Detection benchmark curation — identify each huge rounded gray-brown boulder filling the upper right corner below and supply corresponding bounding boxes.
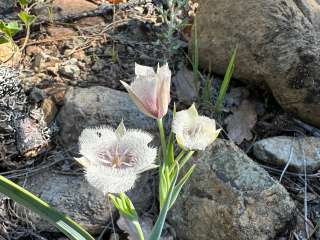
[197,0,320,126]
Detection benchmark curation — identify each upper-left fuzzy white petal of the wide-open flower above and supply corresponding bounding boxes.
[79,127,118,163]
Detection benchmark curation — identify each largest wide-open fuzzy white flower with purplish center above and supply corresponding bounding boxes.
[76,122,157,194]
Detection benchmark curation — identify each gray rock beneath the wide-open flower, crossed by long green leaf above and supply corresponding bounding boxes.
[17,170,153,234]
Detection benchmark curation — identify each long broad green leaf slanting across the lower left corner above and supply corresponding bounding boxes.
[0,175,94,240]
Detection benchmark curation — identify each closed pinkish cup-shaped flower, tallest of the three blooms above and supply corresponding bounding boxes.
[121,63,171,119]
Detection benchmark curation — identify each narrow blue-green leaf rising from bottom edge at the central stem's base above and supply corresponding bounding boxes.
[149,166,179,240]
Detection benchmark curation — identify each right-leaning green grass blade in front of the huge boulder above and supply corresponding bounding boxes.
[215,47,238,113]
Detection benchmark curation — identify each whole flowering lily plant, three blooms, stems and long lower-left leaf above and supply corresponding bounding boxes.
[0,64,220,240]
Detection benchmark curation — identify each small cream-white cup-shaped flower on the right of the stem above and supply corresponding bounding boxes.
[172,104,221,150]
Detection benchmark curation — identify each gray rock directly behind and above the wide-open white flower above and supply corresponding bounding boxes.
[57,86,158,146]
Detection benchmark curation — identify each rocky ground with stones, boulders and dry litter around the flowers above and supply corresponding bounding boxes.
[0,0,320,240]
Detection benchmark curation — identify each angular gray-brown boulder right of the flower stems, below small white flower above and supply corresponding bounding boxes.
[169,140,296,240]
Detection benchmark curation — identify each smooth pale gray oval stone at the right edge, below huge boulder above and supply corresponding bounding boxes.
[253,136,320,173]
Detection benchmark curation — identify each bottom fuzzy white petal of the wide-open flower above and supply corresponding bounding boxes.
[86,165,138,194]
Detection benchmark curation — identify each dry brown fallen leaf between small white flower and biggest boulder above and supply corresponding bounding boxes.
[225,100,257,144]
